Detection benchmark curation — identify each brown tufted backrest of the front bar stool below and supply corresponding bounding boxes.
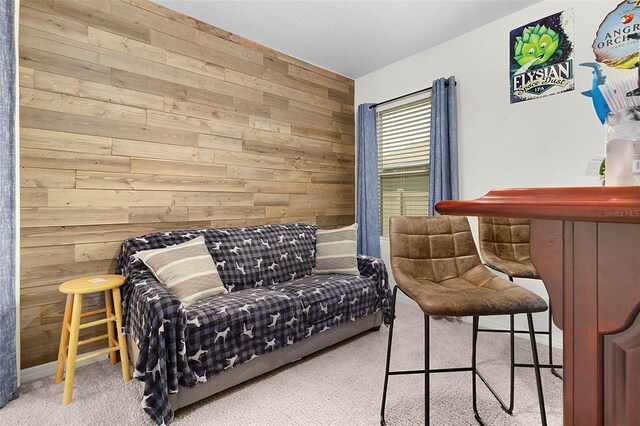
[389,216,481,283]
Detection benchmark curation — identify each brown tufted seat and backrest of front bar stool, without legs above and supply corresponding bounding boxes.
[389,216,547,316]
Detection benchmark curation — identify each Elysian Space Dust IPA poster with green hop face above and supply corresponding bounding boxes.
[509,9,575,104]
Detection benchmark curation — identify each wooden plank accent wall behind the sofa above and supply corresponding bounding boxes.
[20,0,355,368]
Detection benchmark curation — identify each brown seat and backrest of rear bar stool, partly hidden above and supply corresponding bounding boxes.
[478,217,540,279]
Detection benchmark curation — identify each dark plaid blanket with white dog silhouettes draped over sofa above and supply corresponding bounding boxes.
[117,224,391,424]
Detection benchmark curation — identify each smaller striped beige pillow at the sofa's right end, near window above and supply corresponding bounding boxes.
[313,223,360,275]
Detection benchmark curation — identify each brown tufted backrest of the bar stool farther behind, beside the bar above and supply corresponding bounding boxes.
[478,217,531,262]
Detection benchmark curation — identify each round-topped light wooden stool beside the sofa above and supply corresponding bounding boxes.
[54,275,131,404]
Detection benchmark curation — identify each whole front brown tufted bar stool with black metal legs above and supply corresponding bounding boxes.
[380,216,547,426]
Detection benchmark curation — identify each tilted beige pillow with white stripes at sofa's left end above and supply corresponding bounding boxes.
[137,236,227,307]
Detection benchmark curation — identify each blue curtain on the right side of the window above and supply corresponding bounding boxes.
[429,77,458,216]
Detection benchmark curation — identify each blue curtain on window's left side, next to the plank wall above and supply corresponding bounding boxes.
[356,104,380,258]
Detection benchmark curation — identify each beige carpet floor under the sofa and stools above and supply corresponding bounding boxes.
[0,303,562,426]
